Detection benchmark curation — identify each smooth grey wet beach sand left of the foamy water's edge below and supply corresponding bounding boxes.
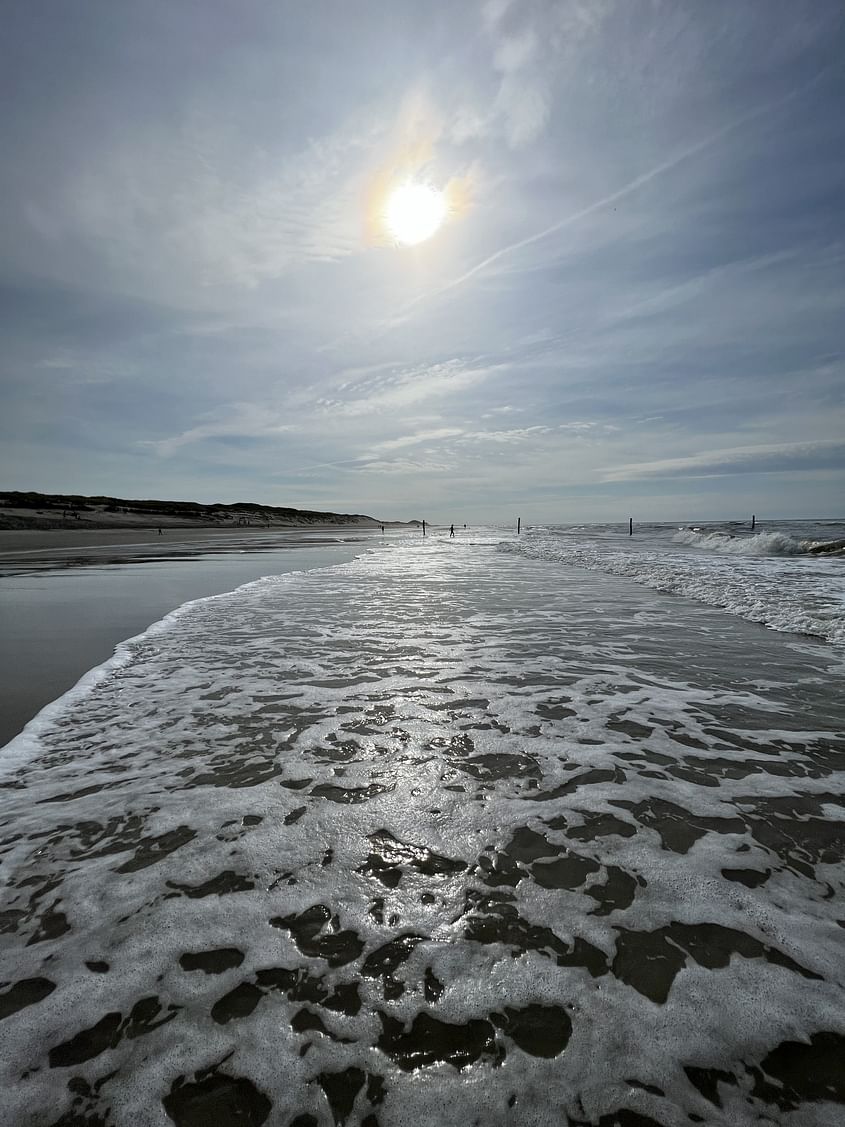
[0,529,372,747]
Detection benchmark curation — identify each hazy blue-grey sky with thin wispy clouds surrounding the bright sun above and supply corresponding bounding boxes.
[0,0,845,524]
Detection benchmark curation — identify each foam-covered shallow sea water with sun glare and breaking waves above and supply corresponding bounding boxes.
[0,522,845,1127]
